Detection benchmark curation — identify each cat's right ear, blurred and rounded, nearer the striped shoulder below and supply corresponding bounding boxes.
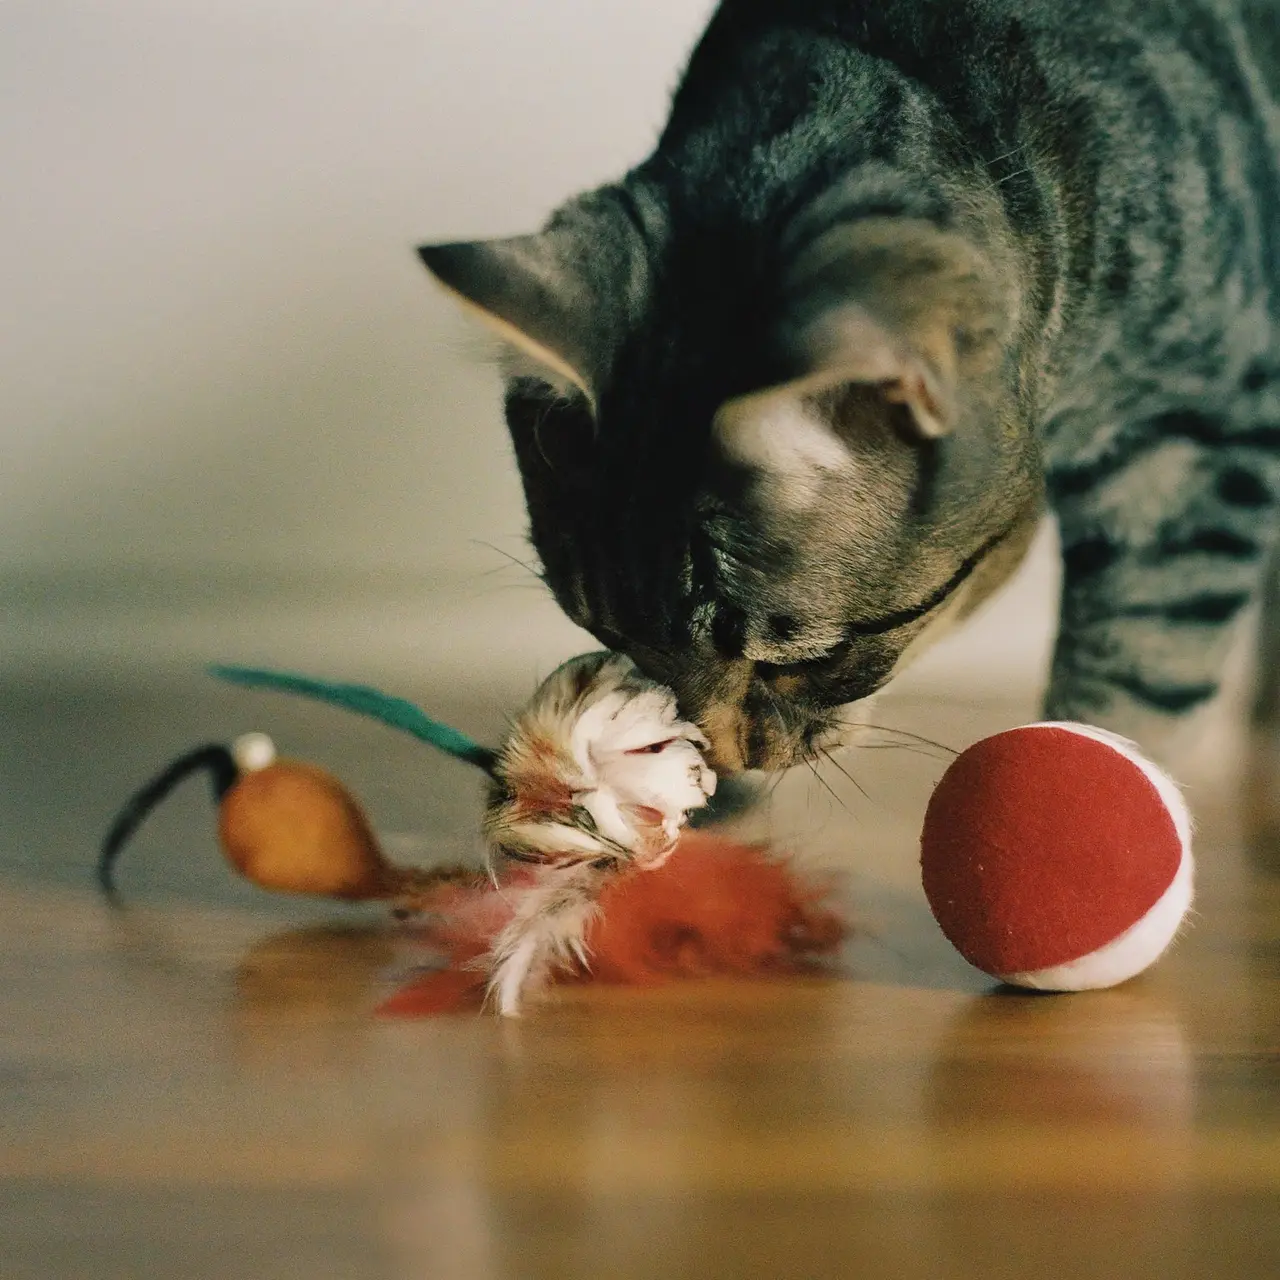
[774,218,1007,438]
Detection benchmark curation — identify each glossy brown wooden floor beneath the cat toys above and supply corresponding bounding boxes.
[0,682,1280,1280]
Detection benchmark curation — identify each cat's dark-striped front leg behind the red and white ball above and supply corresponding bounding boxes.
[1046,412,1280,760]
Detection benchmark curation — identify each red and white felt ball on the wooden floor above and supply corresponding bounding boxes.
[920,723,1192,991]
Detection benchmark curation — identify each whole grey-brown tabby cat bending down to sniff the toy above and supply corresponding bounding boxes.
[421,0,1280,771]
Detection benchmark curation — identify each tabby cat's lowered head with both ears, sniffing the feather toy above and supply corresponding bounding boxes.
[421,180,1041,772]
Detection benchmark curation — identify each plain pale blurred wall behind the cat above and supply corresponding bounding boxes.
[0,0,1056,695]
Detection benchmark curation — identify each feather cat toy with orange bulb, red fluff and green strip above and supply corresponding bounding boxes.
[99,653,844,1015]
